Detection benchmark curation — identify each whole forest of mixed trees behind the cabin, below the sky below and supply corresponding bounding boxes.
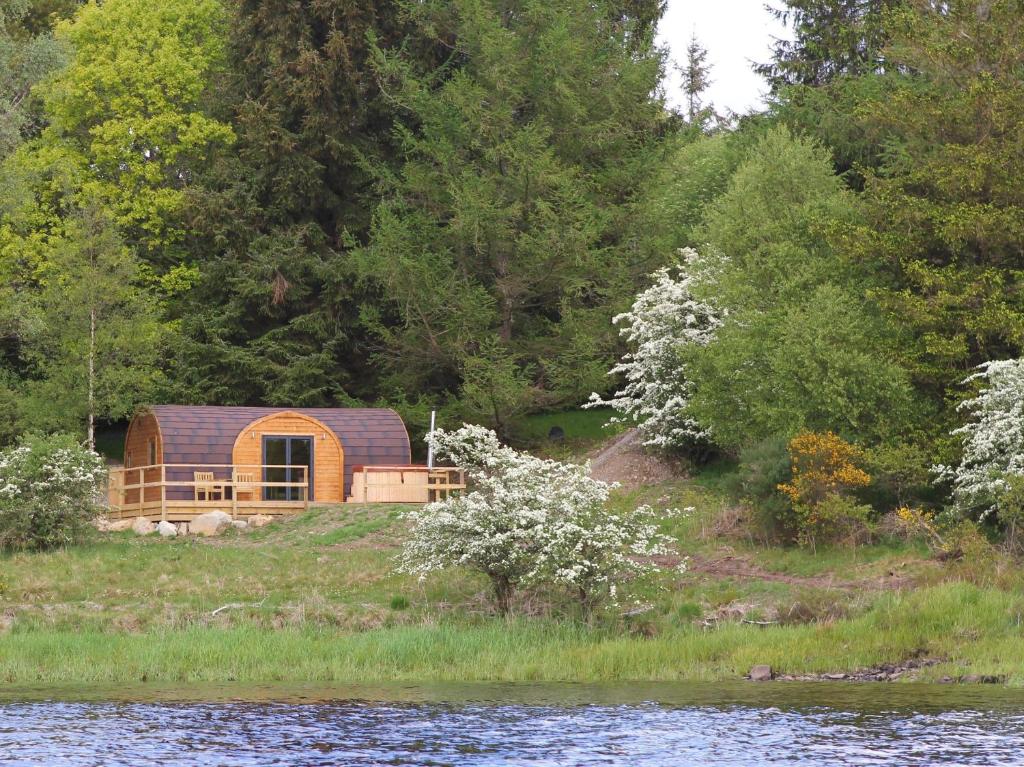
[0,0,1024,520]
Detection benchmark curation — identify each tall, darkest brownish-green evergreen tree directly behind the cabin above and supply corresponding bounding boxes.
[178,0,425,406]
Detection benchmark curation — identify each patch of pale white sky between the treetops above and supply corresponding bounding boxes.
[658,0,788,114]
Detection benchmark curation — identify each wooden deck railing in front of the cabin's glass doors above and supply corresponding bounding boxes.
[108,464,309,519]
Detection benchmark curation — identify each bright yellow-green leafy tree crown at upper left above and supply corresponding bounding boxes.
[8,0,232,268]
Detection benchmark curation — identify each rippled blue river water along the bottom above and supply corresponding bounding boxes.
[0,682,1024,767]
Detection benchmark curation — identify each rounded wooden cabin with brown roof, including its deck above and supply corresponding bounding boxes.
[111,404,461,521]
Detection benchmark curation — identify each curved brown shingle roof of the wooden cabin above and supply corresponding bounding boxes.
[146,404,412,496]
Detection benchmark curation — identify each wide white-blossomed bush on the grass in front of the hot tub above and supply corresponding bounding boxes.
[399,425,669,613]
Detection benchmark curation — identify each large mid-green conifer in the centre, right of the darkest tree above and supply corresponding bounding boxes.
[357,0,668,423]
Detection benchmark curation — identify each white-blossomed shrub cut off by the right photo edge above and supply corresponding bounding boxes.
[935,359,1024,516]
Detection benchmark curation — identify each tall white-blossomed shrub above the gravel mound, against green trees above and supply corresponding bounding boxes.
[584,248,722,450]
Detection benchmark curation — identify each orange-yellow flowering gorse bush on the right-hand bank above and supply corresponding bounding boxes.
[778,431,871,506]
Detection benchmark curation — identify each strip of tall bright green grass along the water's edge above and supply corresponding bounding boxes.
[8,583,1024,685]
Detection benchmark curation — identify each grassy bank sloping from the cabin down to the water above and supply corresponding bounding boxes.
[0,481,1024,685]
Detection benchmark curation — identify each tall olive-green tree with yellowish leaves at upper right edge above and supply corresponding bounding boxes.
[834,0,1024,431]
